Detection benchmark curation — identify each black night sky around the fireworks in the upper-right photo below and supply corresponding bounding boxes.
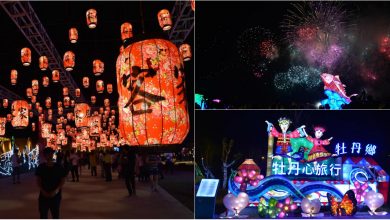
[195,1,390,108]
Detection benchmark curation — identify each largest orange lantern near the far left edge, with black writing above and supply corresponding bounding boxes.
[11,100,28,129]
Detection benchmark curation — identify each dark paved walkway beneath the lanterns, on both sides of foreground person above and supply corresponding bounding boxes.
[0,168,194,219]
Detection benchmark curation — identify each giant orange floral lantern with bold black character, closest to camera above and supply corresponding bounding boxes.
[116,39,190,146]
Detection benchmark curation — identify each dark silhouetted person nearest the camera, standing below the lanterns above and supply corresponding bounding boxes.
[35,147,66,219]
